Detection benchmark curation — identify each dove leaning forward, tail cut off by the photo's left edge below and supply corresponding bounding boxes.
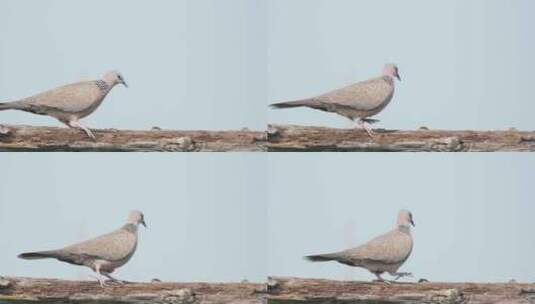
[0,71,128,140]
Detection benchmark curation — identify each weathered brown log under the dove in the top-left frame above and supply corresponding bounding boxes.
[0,126,266,152]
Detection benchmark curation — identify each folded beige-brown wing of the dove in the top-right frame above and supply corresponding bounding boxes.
[314,77,394,111]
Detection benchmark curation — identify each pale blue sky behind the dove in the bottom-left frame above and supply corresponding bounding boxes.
[0,154,267,282]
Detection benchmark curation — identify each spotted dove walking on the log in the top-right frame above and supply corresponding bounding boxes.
[270,63,401,138]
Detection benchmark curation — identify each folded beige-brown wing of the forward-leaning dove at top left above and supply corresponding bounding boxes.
[18,81,103,113]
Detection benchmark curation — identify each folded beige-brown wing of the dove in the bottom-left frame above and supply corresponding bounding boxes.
[62,228,137,261]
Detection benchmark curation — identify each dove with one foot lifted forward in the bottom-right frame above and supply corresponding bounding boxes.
[305,210,415,282]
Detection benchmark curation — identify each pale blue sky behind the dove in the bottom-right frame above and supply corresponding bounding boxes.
[268,154,535,282]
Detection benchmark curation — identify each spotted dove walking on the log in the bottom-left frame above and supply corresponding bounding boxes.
[18,210,147,287]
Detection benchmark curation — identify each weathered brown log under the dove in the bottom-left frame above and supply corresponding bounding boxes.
[0,278,265,304]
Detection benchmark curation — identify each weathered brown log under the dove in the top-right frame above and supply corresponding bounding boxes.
[268,125,535,152]
